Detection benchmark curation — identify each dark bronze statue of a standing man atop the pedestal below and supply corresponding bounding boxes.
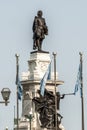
[32,10,48,51]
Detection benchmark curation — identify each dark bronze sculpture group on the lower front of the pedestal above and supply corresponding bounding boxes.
[32,89,64,130]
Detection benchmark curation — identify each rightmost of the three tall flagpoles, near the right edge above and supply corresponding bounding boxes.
[79,52,84,130]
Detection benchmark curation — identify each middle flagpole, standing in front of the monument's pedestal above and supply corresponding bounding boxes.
[53,53,58,130]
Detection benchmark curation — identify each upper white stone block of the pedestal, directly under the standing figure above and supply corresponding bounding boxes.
[28,52,50,80]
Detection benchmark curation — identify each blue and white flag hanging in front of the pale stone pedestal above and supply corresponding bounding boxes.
[40,62,51,96]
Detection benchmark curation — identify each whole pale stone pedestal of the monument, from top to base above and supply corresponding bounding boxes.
[15,52,63,130]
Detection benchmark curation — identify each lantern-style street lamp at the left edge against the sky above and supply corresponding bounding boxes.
[0,88,11,106]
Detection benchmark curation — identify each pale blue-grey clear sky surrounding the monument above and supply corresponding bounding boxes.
[0,0,87,130]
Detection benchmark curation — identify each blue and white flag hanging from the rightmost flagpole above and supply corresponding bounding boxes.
[74,63,82,95]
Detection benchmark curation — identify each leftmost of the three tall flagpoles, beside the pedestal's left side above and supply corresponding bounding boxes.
[15,54,19,130]
